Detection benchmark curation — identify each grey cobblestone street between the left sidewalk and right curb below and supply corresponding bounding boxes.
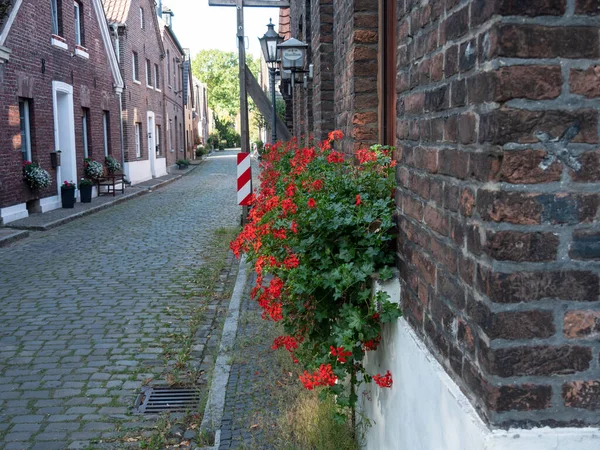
[0,152,240,450]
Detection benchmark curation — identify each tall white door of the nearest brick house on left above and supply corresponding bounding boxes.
[52,81,77,194]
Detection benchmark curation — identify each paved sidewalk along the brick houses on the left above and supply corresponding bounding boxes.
[0,159,204,247]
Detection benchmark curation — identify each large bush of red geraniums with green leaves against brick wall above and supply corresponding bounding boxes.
[231,131,401,419]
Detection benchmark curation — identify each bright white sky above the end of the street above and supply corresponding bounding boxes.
[163,0,279,57]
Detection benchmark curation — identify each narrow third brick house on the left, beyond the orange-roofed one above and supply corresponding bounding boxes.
[159,5,185,171]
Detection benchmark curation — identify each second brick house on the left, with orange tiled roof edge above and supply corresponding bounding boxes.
[104,0,167,184]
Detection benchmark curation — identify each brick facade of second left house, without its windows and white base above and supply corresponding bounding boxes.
[115,0,164,162]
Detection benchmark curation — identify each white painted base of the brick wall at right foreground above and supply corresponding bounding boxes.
[359,286,600,450]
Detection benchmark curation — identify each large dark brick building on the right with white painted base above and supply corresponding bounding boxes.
[286,0,600,449]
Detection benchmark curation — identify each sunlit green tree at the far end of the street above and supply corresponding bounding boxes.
[192,49,259,120]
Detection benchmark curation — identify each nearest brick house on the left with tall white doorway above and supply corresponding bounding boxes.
[0,0,123,223]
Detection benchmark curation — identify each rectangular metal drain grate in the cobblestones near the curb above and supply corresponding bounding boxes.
[133,386,200,414]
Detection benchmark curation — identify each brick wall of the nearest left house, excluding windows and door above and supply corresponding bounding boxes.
[0,0,121,207]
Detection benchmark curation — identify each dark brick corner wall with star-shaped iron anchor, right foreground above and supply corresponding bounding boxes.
[397,0,600,426]
